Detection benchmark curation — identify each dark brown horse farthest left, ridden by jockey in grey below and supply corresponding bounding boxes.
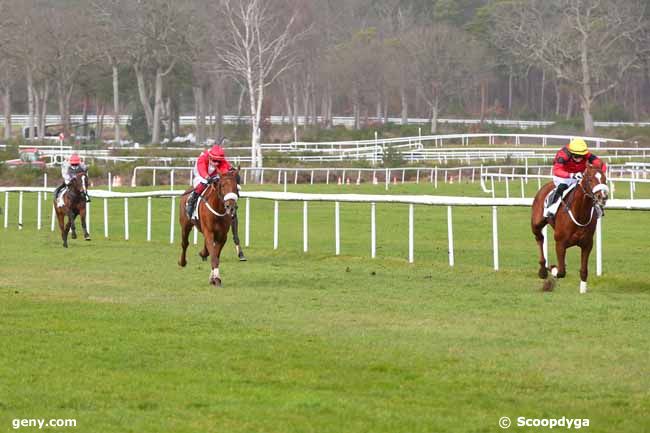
[54,170,90,248]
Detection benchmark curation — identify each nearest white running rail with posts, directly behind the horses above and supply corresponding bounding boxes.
[0,187,650,275]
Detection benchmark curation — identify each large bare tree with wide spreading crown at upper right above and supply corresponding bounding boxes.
[493,0,650,134]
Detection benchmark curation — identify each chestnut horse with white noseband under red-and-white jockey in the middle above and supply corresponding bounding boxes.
[178,170,238,287]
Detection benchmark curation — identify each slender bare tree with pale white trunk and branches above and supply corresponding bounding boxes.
[215,0,301,167]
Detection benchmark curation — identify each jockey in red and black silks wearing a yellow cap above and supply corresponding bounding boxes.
[544,138,607,217]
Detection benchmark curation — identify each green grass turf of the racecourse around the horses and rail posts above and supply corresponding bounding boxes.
[0,180,650,433]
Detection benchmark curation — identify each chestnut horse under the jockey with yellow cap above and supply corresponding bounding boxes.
[531,165,609,293]
